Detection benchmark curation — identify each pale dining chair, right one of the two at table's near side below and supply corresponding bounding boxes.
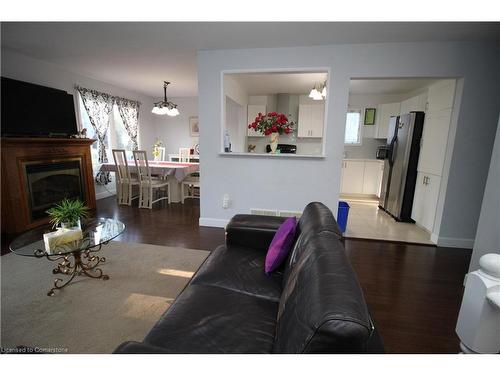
[133,151,170,210]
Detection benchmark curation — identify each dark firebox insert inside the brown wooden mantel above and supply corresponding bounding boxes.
[24,159,84,221]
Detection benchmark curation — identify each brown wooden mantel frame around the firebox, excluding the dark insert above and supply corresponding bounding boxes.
[1,138,96,234]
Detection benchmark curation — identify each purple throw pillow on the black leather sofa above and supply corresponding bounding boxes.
[264,217,297,274]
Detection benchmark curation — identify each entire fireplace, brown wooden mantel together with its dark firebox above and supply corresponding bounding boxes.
[1,138,96,234]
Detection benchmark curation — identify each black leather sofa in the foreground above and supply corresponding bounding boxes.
[115,202,383,353]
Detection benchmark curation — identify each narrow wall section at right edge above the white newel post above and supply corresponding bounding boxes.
[469,118,500,272]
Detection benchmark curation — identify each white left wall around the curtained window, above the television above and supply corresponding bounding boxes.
[1,48,154,199]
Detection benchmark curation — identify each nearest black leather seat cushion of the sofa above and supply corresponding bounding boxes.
[144,284,278,354]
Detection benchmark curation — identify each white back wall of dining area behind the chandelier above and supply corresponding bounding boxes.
[152,97,199,155]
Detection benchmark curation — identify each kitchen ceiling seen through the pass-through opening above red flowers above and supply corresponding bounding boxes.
[229,73,328,95]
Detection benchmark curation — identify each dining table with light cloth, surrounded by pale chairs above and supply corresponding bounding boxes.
[100,160,200,182]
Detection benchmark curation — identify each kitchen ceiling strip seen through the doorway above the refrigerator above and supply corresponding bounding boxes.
[349,78,438,95]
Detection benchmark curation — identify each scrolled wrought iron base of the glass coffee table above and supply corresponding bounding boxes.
[35,245,109,297]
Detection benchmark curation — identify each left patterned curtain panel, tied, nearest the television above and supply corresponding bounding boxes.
[76,86,113,185]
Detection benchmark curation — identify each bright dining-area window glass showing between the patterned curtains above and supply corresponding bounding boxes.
[78,95,132,176]
